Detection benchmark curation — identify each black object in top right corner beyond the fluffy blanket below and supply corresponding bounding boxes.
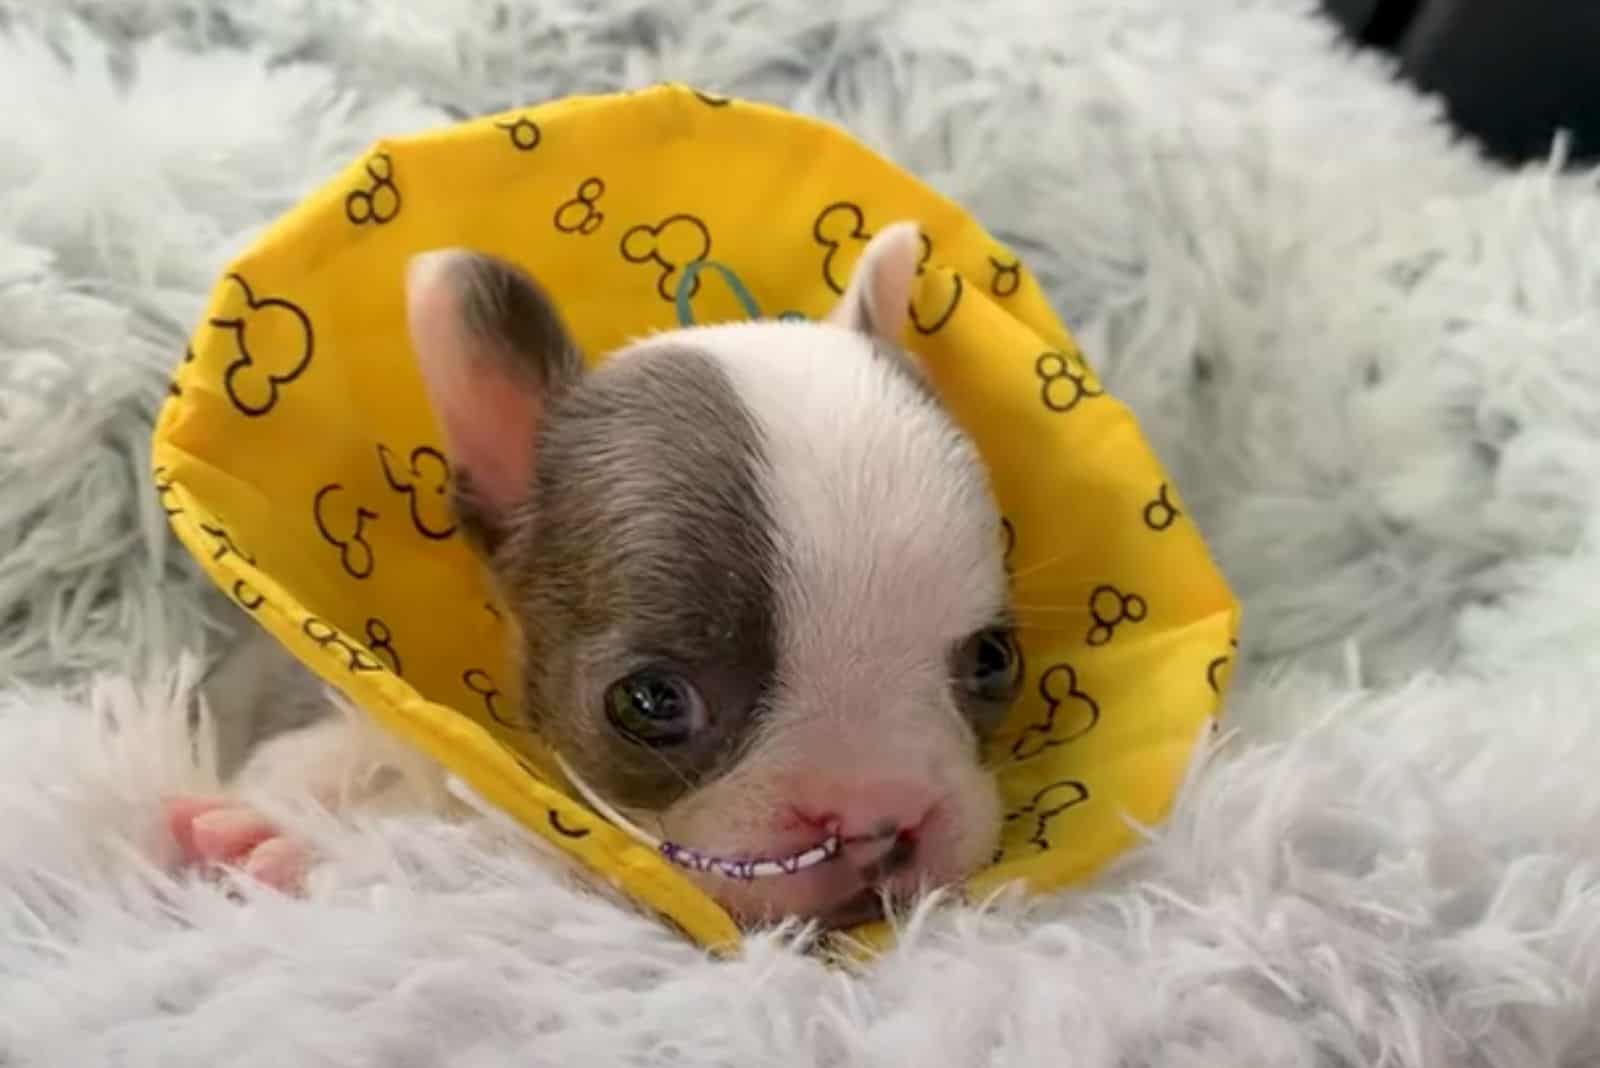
[1322,0,1600,163]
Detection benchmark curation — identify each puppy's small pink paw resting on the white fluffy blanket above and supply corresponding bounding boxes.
[165,796,310,894]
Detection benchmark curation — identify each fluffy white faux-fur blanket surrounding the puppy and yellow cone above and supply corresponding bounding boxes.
[0,0,1600,1068]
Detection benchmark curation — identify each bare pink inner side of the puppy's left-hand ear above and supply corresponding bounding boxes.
[406,253,544,515]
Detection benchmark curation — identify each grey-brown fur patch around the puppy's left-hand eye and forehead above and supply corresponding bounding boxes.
[493,345,776,809]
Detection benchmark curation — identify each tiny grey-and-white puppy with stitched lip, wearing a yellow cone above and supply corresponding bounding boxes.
[170,224,1021,926]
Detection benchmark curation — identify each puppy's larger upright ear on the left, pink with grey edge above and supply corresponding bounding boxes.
[405,249,584,552]
